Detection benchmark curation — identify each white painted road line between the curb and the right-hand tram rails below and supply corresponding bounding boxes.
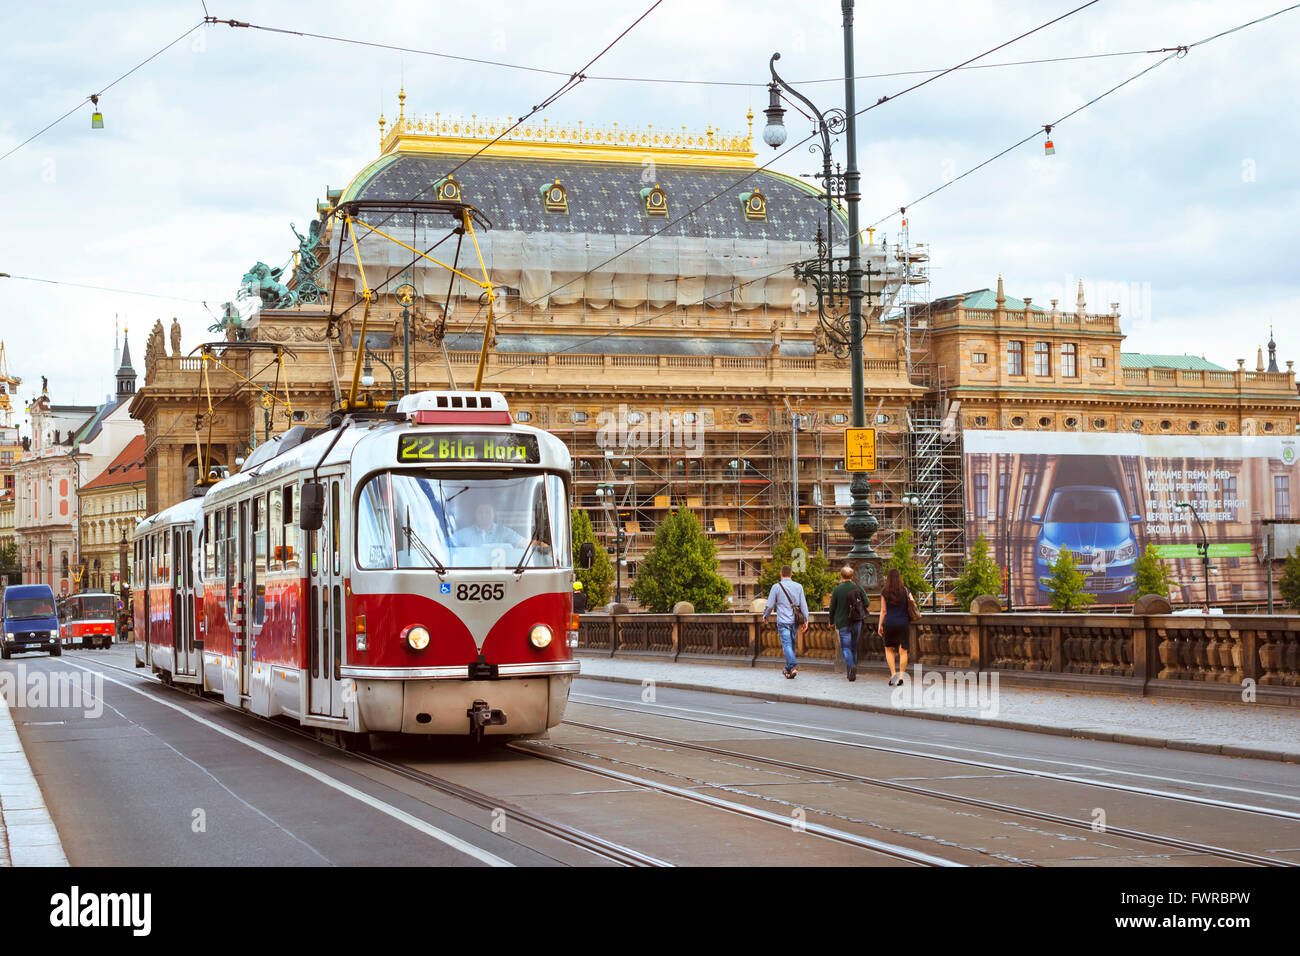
[569,693,1300,819]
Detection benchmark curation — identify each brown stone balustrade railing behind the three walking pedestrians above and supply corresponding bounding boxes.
[579,613,1300,706]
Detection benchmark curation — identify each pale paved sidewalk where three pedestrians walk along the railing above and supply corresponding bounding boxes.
[579,652,1300,763]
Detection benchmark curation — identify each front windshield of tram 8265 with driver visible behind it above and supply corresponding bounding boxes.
[356,471,571,571]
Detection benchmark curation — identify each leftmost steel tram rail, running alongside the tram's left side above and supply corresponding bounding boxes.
[69,654,672,866]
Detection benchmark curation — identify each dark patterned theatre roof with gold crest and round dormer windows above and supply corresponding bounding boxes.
[342,107,845,242]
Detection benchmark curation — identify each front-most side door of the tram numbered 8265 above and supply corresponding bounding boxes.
[308,476,347,717]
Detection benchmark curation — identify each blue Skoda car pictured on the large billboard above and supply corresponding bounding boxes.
[1031,485,1141,597]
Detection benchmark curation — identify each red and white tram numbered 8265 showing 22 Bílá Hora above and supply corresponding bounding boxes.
[135,392,579,736]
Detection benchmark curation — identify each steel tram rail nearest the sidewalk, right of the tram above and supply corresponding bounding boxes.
[553,719,1300,868]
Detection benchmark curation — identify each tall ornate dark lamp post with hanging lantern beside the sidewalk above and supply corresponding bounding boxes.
[763,0,880,574]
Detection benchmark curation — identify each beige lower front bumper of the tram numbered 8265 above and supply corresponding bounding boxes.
[356,674,573,736]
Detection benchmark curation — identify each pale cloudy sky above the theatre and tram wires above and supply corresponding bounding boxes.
[0,0,1300,416]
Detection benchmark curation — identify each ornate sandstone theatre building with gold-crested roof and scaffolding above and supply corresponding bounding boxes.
[131,95,1297,606]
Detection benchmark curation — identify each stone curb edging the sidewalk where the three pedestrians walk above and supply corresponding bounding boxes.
[579,674,1300,763]
